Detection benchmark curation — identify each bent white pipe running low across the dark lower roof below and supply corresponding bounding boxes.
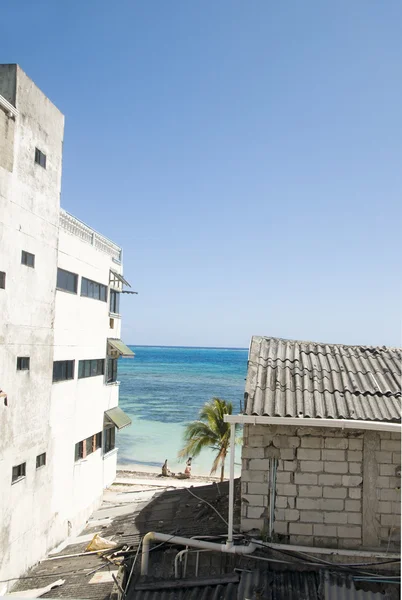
[141,531,257,575]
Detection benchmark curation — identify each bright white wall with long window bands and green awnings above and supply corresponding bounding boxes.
[51,229,125,533]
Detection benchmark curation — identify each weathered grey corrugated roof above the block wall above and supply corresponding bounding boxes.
[245,336,402,422]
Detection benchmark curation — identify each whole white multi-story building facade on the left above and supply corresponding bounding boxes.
[0,65,132,593]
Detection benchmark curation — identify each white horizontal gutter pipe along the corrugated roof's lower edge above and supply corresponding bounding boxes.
[223,415,402,433]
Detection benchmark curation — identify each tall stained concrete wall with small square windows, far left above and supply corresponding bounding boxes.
[0,65,64,590]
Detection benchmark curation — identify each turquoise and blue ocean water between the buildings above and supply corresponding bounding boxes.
[117,346,248,476]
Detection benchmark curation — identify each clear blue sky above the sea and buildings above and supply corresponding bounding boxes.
[0,0,402,347]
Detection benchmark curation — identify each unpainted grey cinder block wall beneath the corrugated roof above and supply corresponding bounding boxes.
[241,425,401,549]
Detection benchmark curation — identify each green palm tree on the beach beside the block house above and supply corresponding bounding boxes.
[179,398,237,481]
